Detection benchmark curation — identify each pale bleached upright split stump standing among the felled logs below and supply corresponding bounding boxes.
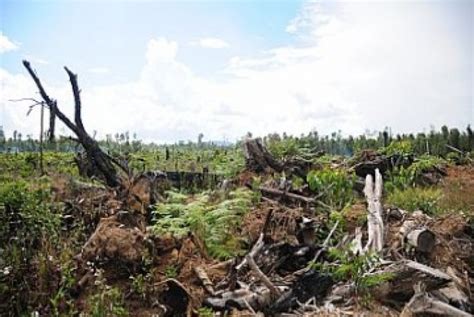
[364,169,384,253]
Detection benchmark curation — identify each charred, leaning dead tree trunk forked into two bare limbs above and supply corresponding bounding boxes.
[23,60,121,187]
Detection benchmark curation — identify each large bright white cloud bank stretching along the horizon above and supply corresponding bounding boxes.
[0,2,474,142]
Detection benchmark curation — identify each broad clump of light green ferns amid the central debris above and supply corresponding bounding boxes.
[151,188,253,259]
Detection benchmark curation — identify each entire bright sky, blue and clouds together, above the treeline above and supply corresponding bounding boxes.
[0,0,474,142]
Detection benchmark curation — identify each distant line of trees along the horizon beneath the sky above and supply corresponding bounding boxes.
[0,126,474,157]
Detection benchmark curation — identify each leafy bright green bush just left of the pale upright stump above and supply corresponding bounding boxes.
[307,168,354,210]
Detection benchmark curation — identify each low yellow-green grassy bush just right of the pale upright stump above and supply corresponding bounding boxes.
[387,187,442,214]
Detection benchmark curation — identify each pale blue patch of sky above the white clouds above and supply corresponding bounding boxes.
[1,0,302,85]
